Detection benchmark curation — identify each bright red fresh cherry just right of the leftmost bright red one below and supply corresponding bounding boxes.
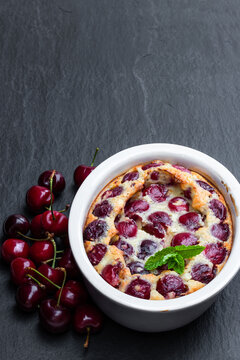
[29,240,54,264]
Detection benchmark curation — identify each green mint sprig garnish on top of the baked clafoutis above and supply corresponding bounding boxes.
[144,245,205,274]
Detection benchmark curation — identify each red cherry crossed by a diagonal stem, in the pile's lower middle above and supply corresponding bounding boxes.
[35,264,64,293]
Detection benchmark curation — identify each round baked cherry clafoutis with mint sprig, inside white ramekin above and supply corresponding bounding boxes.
[83,160,232,300]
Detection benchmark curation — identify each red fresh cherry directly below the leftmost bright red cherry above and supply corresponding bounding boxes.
[11,257,36,285]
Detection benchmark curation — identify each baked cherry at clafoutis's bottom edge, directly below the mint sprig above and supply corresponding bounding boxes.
[157,274,188,298]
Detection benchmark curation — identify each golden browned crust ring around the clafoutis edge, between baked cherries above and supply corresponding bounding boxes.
[84,160,233,300]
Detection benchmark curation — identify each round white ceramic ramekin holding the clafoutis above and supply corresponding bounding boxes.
[69,144,240,332]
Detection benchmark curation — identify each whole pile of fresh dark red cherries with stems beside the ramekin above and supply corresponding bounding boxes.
[1,148,103,348]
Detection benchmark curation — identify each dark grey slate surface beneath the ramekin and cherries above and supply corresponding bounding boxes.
[0,0,240,360]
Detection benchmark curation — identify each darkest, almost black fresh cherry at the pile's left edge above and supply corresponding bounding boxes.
[3,214,30,237]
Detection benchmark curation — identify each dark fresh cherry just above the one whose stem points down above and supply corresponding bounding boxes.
[55,280,88,310]
